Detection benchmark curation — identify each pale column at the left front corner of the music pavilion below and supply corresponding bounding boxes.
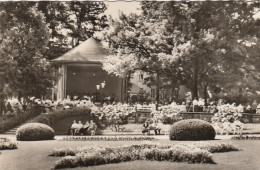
[57,63,67,100]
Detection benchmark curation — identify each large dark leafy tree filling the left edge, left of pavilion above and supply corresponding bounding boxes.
[0,2,55,109]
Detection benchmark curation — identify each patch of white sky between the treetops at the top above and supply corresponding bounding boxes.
[105,1,140,19]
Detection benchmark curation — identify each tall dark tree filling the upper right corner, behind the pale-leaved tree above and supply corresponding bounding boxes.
[142,2,259,101]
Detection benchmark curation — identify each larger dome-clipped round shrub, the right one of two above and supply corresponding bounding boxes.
[169,119,216,140]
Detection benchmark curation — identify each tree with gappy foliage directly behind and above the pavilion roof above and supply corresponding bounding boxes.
[38,1,107,59]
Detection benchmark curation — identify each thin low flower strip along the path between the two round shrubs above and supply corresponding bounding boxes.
[61,136,155,141]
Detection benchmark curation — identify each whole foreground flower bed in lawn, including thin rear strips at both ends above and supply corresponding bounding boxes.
[49,143,239,169]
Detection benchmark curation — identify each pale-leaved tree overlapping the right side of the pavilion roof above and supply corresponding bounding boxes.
[103,14,177,101]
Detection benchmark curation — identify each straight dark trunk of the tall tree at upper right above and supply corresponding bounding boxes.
[192,57,199,100]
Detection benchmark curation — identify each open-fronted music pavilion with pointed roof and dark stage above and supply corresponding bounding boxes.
[52,38,126,102]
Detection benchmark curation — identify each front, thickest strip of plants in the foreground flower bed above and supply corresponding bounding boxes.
[52,145,213,169]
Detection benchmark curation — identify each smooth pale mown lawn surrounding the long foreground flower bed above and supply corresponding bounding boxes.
[0,135,260,170]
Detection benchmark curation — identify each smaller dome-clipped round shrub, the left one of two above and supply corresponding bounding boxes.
[16,123,54,141]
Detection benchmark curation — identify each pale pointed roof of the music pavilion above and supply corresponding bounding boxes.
[52,38,108,63]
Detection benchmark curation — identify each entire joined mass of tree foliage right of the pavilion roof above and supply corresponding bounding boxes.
[101,1,259,101]
